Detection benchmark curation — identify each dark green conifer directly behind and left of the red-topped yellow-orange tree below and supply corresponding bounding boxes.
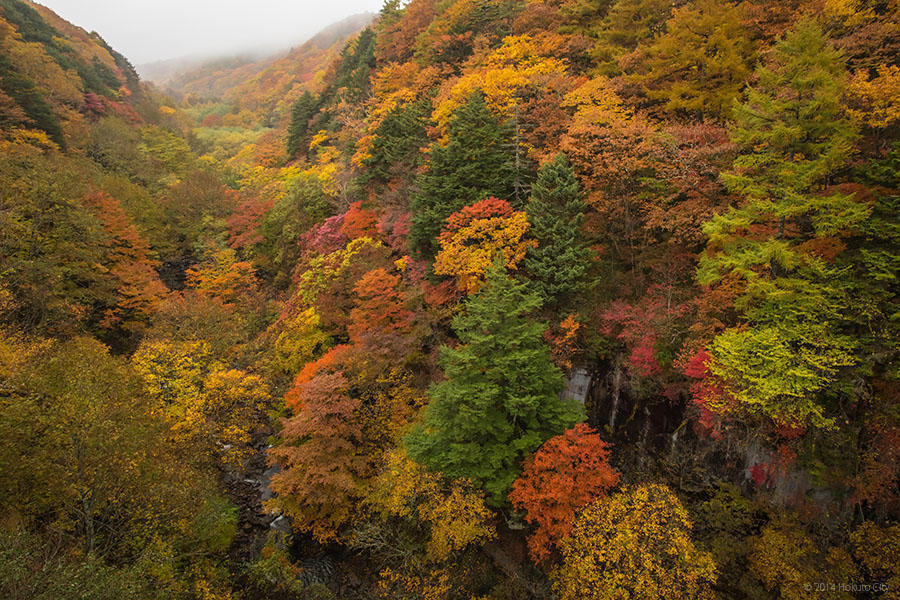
[409,92,515,258]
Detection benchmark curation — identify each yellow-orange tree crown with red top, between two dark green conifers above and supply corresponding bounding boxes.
[434,198,537,294]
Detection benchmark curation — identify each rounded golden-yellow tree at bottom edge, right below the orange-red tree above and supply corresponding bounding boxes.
[553,484,716,600]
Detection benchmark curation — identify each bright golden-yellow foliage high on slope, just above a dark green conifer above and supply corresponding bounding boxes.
[433,35,566,129]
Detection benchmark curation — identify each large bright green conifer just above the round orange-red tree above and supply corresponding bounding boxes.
[406,264,580,506]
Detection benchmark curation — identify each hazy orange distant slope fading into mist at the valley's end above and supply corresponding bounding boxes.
[155,13,375,120]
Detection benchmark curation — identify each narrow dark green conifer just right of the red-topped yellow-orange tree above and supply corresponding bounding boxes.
[523,154,593,310]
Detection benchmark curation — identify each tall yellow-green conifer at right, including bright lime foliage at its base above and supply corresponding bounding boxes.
[698,20,871,426]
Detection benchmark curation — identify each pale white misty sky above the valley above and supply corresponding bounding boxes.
[37,0,384,65]
